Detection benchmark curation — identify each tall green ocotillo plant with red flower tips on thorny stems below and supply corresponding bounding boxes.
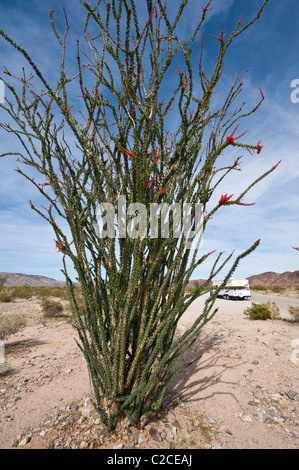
[0,0,277,430]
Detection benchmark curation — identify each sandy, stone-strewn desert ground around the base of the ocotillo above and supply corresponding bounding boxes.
[0,293,299,449]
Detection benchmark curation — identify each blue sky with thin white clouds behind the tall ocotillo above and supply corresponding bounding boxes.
[0,0,299,280]
